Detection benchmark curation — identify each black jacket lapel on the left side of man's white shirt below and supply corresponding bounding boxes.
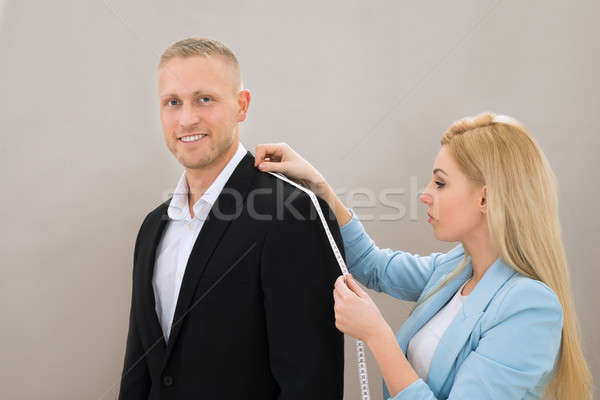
[138,199,170,365]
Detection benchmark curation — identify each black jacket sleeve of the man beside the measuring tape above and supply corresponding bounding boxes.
[261,193,344,400]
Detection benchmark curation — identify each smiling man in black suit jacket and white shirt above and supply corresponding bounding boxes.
[119,38,344,400]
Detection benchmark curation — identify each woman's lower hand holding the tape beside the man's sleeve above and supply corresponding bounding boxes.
[333,275,393,344]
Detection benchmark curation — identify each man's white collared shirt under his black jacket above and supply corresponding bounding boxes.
[152,143,246,342]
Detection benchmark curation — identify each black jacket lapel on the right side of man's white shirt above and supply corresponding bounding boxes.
[165,152,257,363]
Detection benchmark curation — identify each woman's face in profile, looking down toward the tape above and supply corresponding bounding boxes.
[420,146,487,242]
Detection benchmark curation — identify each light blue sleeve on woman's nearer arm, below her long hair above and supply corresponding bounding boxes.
[391,279,563,400]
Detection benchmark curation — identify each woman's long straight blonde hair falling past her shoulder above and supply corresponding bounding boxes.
[420,113,592,400]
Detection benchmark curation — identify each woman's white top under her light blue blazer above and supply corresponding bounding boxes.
[406,282,469,382]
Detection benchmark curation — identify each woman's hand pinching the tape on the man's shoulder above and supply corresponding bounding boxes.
[254,143,327,194]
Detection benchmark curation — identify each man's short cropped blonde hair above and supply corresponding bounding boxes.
[158,37,242,89]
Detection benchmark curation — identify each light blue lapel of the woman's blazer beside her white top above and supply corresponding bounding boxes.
[427,258,516,395]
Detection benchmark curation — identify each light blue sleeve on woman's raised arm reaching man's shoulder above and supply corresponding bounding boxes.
[340,209,452,301]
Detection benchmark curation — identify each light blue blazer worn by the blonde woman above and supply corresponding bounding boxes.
[340,213,563,400]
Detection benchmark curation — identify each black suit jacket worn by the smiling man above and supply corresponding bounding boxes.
[119,152,344,400]
